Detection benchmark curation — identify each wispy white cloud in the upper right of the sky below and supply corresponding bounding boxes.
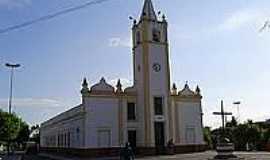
[218,9,268,30]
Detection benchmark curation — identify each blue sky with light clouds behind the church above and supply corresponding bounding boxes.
[0,0,270,126]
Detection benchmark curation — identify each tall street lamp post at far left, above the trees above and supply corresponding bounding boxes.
[5,63,21,154]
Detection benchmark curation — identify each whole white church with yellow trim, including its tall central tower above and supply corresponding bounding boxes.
[40,0,205,156]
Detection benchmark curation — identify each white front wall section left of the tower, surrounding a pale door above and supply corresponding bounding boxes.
[85,97,119,148]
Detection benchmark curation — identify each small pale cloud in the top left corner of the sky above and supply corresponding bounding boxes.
[0,0,31,9]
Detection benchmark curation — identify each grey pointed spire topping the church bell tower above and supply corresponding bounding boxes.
[141,0,157,20]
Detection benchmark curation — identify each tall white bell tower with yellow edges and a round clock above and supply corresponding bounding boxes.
[132,0,170,148]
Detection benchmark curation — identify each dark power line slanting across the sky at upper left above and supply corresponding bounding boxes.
[0,0,112,34]
